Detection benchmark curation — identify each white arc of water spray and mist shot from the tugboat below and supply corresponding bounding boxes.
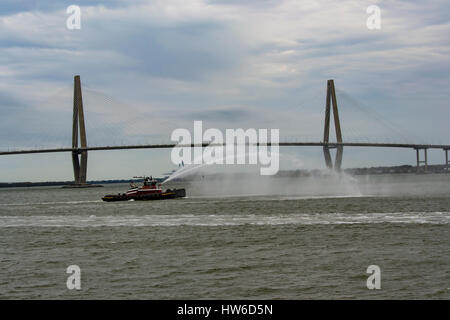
[163,153,361,197]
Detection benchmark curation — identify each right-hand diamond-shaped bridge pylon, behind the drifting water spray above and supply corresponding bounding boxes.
[323,80,344,171]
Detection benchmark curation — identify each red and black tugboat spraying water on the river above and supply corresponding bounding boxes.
[102,177,186,202]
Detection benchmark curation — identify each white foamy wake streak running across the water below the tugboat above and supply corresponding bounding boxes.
[0,212,450,228]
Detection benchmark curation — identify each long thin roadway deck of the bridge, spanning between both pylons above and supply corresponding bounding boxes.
[0,142,450,156]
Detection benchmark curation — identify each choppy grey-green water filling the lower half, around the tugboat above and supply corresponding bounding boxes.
[0,175,450,299]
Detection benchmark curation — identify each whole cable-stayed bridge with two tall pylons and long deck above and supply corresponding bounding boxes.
[0,75,450,186]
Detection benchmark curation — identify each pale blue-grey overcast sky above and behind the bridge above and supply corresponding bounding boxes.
[0,0,450,182]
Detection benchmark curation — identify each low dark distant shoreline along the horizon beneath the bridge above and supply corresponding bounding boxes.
[0,165,446,188]
